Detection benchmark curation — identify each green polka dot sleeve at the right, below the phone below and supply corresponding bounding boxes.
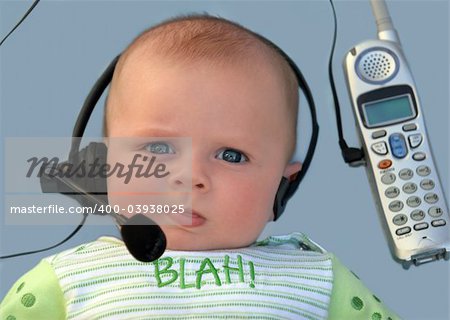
[328,256,400,320]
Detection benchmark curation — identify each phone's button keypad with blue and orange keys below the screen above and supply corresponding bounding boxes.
[371,123,447,236]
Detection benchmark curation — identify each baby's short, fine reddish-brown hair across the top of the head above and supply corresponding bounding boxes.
[103,14,299,161]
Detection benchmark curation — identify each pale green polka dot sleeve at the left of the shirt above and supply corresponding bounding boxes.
[0,260,66,320]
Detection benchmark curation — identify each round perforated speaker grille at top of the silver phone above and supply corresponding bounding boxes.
[357,48,398,83]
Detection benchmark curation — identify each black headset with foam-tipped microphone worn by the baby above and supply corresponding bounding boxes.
[1,7,319,262]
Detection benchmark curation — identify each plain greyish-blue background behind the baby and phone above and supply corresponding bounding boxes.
[0,0,450,320]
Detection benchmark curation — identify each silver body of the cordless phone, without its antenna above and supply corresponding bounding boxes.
[344,40,450,268]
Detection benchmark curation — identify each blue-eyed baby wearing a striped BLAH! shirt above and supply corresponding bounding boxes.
[0,16,398,320]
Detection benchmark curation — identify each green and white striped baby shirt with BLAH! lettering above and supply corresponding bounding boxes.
[1,233,395,320]
